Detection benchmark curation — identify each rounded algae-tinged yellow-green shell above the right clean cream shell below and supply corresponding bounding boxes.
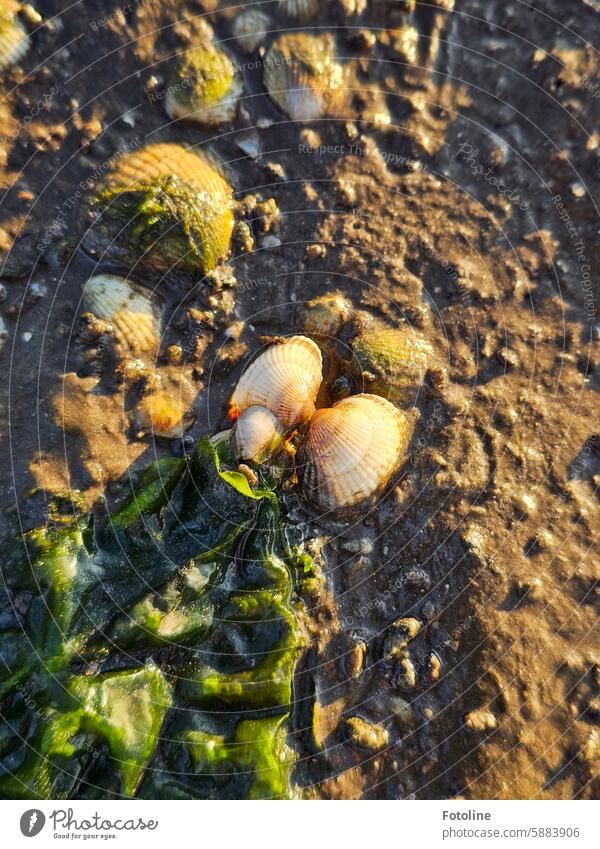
[352,324,433,401]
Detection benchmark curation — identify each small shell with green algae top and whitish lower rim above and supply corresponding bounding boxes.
[165,42,243,125]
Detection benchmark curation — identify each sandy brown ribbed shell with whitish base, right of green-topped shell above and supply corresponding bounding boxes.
[263,32,344,121]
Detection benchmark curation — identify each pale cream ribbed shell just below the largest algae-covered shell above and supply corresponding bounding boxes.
[83,274,160,357]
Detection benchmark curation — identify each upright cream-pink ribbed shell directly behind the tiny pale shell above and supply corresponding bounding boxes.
[229,336,323,428]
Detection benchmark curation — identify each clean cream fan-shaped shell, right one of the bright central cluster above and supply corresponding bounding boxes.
[298,395,410,510]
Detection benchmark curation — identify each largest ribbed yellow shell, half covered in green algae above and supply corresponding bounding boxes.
[82,142,234,275]
